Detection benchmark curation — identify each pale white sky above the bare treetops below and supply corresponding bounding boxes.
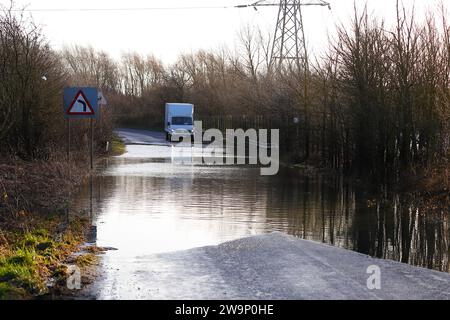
[0,0,446,63]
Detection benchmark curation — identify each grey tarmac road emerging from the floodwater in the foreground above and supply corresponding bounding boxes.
[87,233,450,300]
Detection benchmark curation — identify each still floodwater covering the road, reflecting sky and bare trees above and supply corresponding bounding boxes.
[75,145,450,297]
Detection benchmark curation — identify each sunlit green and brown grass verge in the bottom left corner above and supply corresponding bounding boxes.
[0,215,96,300]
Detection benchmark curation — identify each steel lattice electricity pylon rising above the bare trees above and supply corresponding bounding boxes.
[237,0,330,69]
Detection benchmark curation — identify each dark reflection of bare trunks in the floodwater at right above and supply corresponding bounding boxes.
[267,175,450,272]
